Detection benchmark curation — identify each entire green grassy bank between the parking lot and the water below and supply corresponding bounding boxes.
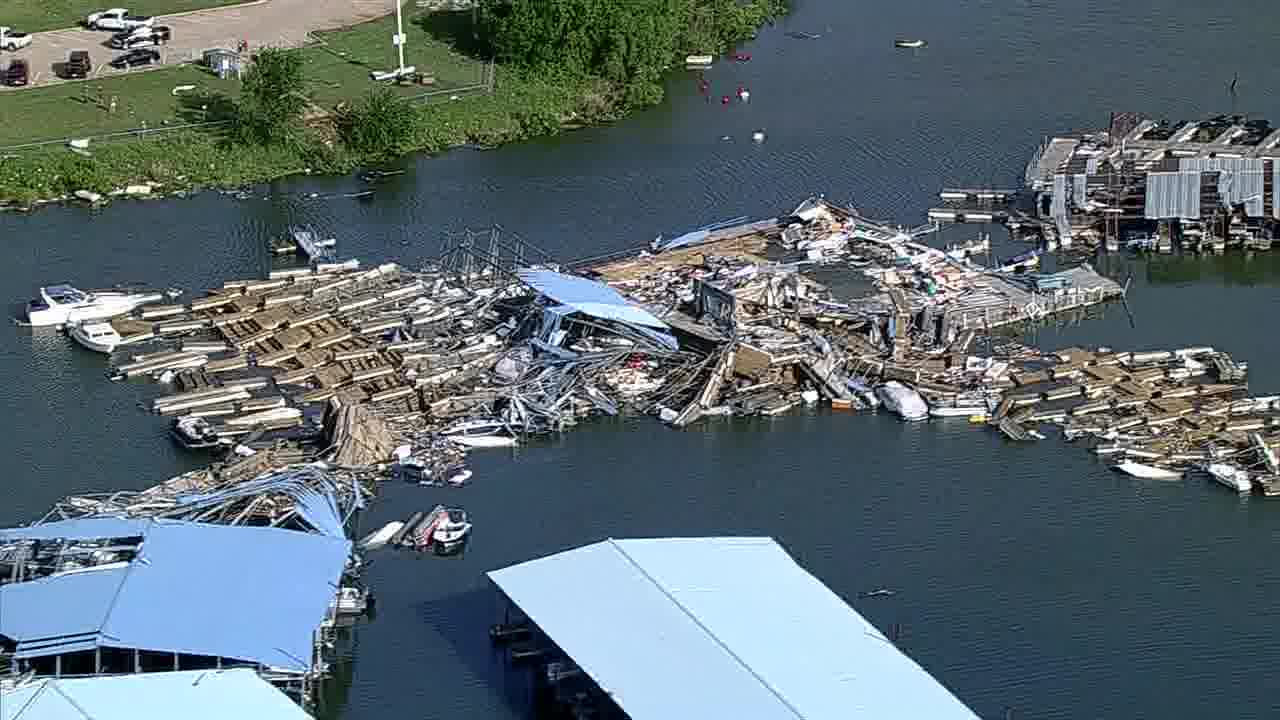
[0,4,783,208]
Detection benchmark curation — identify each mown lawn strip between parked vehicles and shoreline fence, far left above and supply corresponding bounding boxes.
[0,65,238,146]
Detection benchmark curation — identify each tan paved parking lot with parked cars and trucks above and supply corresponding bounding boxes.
[0,0,393,91]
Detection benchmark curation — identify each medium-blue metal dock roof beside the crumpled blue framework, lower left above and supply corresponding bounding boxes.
[0,520,351,671]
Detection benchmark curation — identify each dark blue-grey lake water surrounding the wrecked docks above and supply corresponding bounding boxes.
[0,0,1280,720]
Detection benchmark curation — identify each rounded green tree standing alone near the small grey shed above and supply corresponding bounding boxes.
[234,47,311,145]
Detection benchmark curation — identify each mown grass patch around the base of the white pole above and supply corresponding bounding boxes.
[300,17,484,106]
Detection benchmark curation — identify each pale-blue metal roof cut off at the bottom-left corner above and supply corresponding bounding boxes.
[0,667,311,720]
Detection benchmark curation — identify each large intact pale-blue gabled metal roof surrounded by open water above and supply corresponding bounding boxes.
[489,538,978,720]
